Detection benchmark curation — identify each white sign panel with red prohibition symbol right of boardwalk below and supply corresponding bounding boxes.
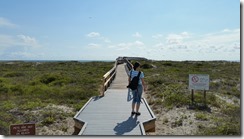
[189,74,209,90]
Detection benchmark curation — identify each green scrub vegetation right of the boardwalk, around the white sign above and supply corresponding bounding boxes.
[132,61,241,135]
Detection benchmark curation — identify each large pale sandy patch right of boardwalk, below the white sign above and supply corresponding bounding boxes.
[144,93,205,135]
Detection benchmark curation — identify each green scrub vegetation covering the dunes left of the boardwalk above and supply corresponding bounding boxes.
[0,61,114,135]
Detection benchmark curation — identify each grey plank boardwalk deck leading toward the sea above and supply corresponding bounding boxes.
[74,64,156,135]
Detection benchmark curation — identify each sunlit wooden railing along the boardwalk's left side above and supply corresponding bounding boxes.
[101,60,117,96]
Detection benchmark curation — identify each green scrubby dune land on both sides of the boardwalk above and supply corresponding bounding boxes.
[0,61,241,135]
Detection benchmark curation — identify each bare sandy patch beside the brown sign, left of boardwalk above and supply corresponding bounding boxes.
[10,104,75,135]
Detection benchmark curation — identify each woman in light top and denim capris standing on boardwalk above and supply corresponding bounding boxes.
[128,62,146,116]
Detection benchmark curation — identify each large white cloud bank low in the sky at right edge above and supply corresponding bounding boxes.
[152,29,240,55]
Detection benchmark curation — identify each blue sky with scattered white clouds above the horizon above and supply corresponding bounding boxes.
[0,0,241,61]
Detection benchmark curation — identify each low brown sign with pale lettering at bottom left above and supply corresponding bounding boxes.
[10,124,36,135]
